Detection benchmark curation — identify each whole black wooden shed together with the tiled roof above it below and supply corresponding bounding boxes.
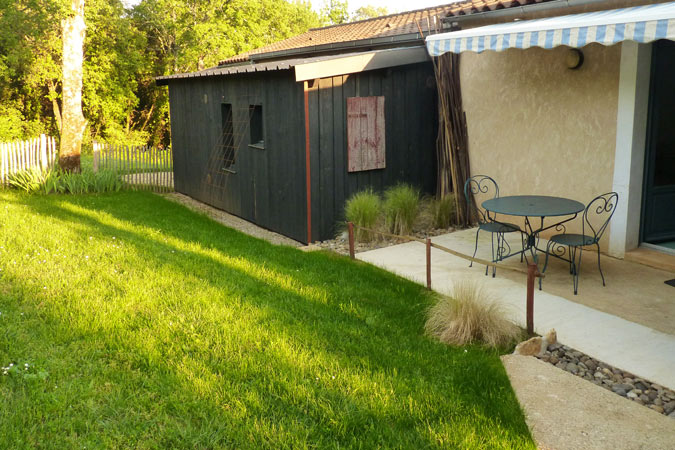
[157,4,456,243]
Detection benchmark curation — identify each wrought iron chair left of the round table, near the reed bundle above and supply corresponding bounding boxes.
[464,175,523,278]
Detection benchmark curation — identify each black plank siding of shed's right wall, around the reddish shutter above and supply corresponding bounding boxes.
[309,63,438,240]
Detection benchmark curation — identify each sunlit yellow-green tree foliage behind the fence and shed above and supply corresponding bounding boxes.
[0,0,322,146]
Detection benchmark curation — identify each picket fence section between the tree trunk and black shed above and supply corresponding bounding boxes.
[93,142,173,192]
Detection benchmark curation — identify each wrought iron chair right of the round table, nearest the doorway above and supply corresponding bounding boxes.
[539,192,619,295]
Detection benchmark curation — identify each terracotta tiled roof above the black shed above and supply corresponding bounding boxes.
[220,0,551,65]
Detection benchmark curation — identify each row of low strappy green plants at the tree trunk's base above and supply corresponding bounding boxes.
[8,167,122,194]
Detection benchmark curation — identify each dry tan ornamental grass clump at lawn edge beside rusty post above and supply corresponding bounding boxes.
[425,282,522,348]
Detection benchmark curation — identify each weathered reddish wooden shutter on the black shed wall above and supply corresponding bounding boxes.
[347,96,385,172]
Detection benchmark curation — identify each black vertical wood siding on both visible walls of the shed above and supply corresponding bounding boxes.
[169,63,438,242]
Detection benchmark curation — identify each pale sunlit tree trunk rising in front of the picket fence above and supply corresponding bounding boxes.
[59,0,87,172]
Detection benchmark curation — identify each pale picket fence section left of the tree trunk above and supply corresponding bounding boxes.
[0,134,58,186]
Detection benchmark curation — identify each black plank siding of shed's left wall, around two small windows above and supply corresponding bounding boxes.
[169,71,307,241]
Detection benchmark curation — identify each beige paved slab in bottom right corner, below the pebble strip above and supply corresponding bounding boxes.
[502,355,675,450]
